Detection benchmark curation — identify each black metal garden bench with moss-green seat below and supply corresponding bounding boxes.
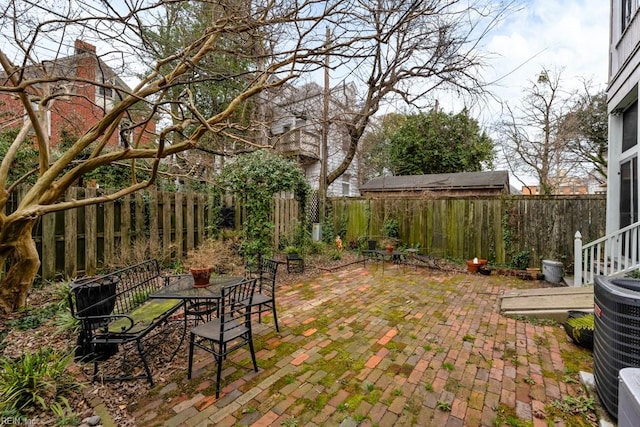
[69,260,186,385]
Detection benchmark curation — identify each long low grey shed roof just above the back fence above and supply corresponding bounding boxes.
[360,171,511,197]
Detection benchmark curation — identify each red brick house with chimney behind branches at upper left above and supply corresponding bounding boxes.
[0,40,155,151]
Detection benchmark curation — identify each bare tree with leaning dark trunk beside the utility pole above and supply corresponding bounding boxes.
[325,0,514,201]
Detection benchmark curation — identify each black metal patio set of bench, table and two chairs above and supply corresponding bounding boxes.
[68,259,279,397]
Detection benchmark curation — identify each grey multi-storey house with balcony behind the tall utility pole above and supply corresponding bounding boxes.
[268,83,358,197]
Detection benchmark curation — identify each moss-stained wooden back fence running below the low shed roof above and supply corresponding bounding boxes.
[332,195,606,267]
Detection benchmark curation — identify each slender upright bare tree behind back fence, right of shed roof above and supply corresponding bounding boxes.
[499,69,578,194]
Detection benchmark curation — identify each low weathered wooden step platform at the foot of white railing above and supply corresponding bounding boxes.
[500,286,593,322]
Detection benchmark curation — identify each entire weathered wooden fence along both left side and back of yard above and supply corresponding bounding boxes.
[3,188,606,280]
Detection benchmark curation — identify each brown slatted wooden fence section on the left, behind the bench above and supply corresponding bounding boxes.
[7,188,214,280]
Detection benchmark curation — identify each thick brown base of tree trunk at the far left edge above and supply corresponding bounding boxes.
[0,219,40,314]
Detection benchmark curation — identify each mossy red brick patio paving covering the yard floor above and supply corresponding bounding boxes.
[135,263,596,427]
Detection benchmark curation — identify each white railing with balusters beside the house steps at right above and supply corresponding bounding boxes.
[574,222,640,286]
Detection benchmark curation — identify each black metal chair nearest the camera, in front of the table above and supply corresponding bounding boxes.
[187,279,258,399]
